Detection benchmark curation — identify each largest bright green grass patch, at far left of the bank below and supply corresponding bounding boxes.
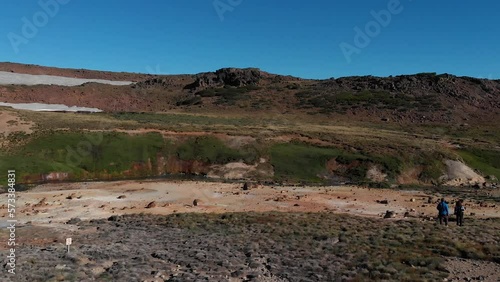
[0,132,163,181]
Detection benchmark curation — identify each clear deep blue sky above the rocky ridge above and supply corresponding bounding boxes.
[0,0,500,78]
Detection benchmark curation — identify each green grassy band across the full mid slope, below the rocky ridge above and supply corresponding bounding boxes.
[0,108,500,187]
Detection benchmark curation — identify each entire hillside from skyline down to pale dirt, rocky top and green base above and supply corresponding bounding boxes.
[0,65,500,186]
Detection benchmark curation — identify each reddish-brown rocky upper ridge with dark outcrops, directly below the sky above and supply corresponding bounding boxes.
[0,63,500,125]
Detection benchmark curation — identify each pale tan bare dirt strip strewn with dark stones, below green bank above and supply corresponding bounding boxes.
[0,181,500,223]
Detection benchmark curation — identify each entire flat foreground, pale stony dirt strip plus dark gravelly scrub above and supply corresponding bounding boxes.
[0,181,500,281]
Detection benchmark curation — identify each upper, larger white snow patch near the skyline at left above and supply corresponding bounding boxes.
[0,71,133,86]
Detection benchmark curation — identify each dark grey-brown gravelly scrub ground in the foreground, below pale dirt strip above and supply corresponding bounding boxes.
[4,213,499,282]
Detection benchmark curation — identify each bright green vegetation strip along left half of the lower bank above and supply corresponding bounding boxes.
[0,132,258,182]
